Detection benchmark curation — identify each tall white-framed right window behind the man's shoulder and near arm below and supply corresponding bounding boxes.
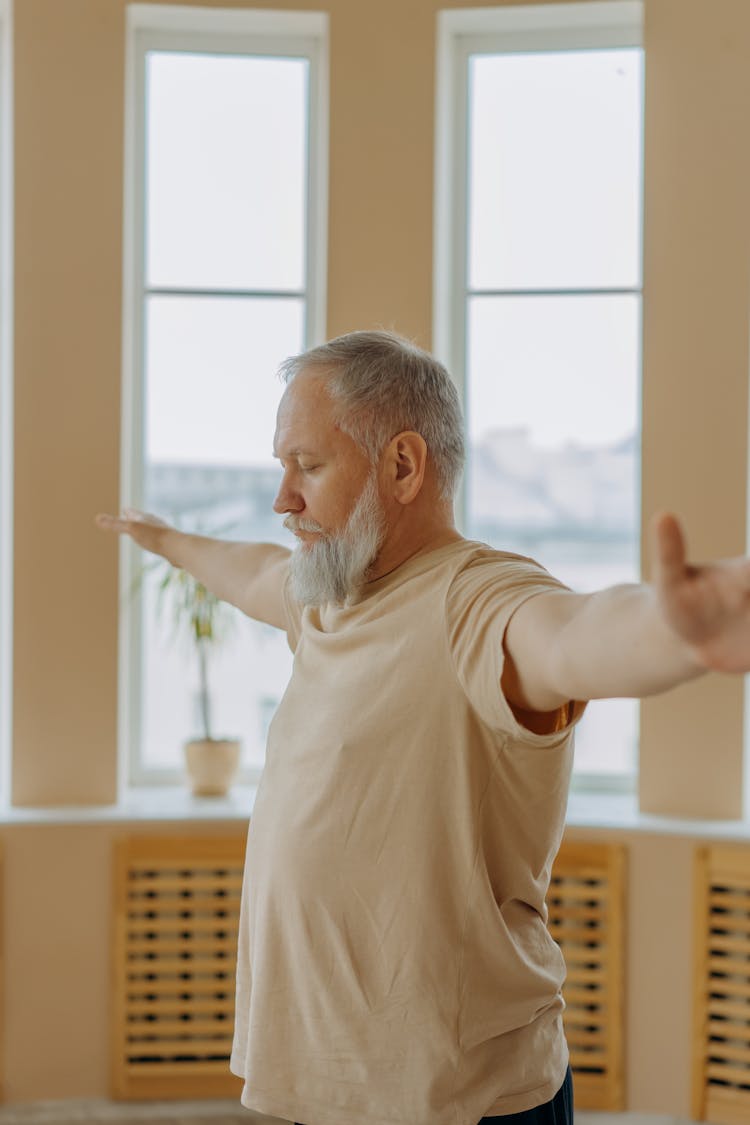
[435,2,643,788]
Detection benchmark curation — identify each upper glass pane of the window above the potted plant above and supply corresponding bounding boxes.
[146,52,309,289]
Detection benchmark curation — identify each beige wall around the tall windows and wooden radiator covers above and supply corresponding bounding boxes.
[3,0,750,1114]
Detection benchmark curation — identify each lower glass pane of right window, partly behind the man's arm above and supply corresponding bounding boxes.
[467,296,640,773]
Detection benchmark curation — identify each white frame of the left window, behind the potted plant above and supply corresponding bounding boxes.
[118,3,328,793]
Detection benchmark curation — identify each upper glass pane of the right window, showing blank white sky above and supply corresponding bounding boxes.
[469,48,642,289]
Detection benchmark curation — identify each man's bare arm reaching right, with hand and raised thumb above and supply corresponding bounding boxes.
[503,515,750,711]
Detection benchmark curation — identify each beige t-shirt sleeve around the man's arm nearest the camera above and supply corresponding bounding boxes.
[445,550,584,746]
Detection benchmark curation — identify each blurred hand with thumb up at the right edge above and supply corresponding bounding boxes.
[652,514,750,672]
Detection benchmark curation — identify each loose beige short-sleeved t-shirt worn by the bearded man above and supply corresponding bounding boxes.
[232,540,581,1125]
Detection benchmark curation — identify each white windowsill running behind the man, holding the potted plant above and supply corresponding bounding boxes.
[0,785,750,842]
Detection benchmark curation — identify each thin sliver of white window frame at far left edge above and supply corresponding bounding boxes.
[0,0,13,808]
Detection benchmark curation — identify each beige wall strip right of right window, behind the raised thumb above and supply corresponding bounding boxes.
[641,0,750,817]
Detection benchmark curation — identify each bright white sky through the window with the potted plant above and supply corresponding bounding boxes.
[146,52,309,466]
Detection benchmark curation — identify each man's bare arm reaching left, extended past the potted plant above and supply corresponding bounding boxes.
[94,509,290,629]
